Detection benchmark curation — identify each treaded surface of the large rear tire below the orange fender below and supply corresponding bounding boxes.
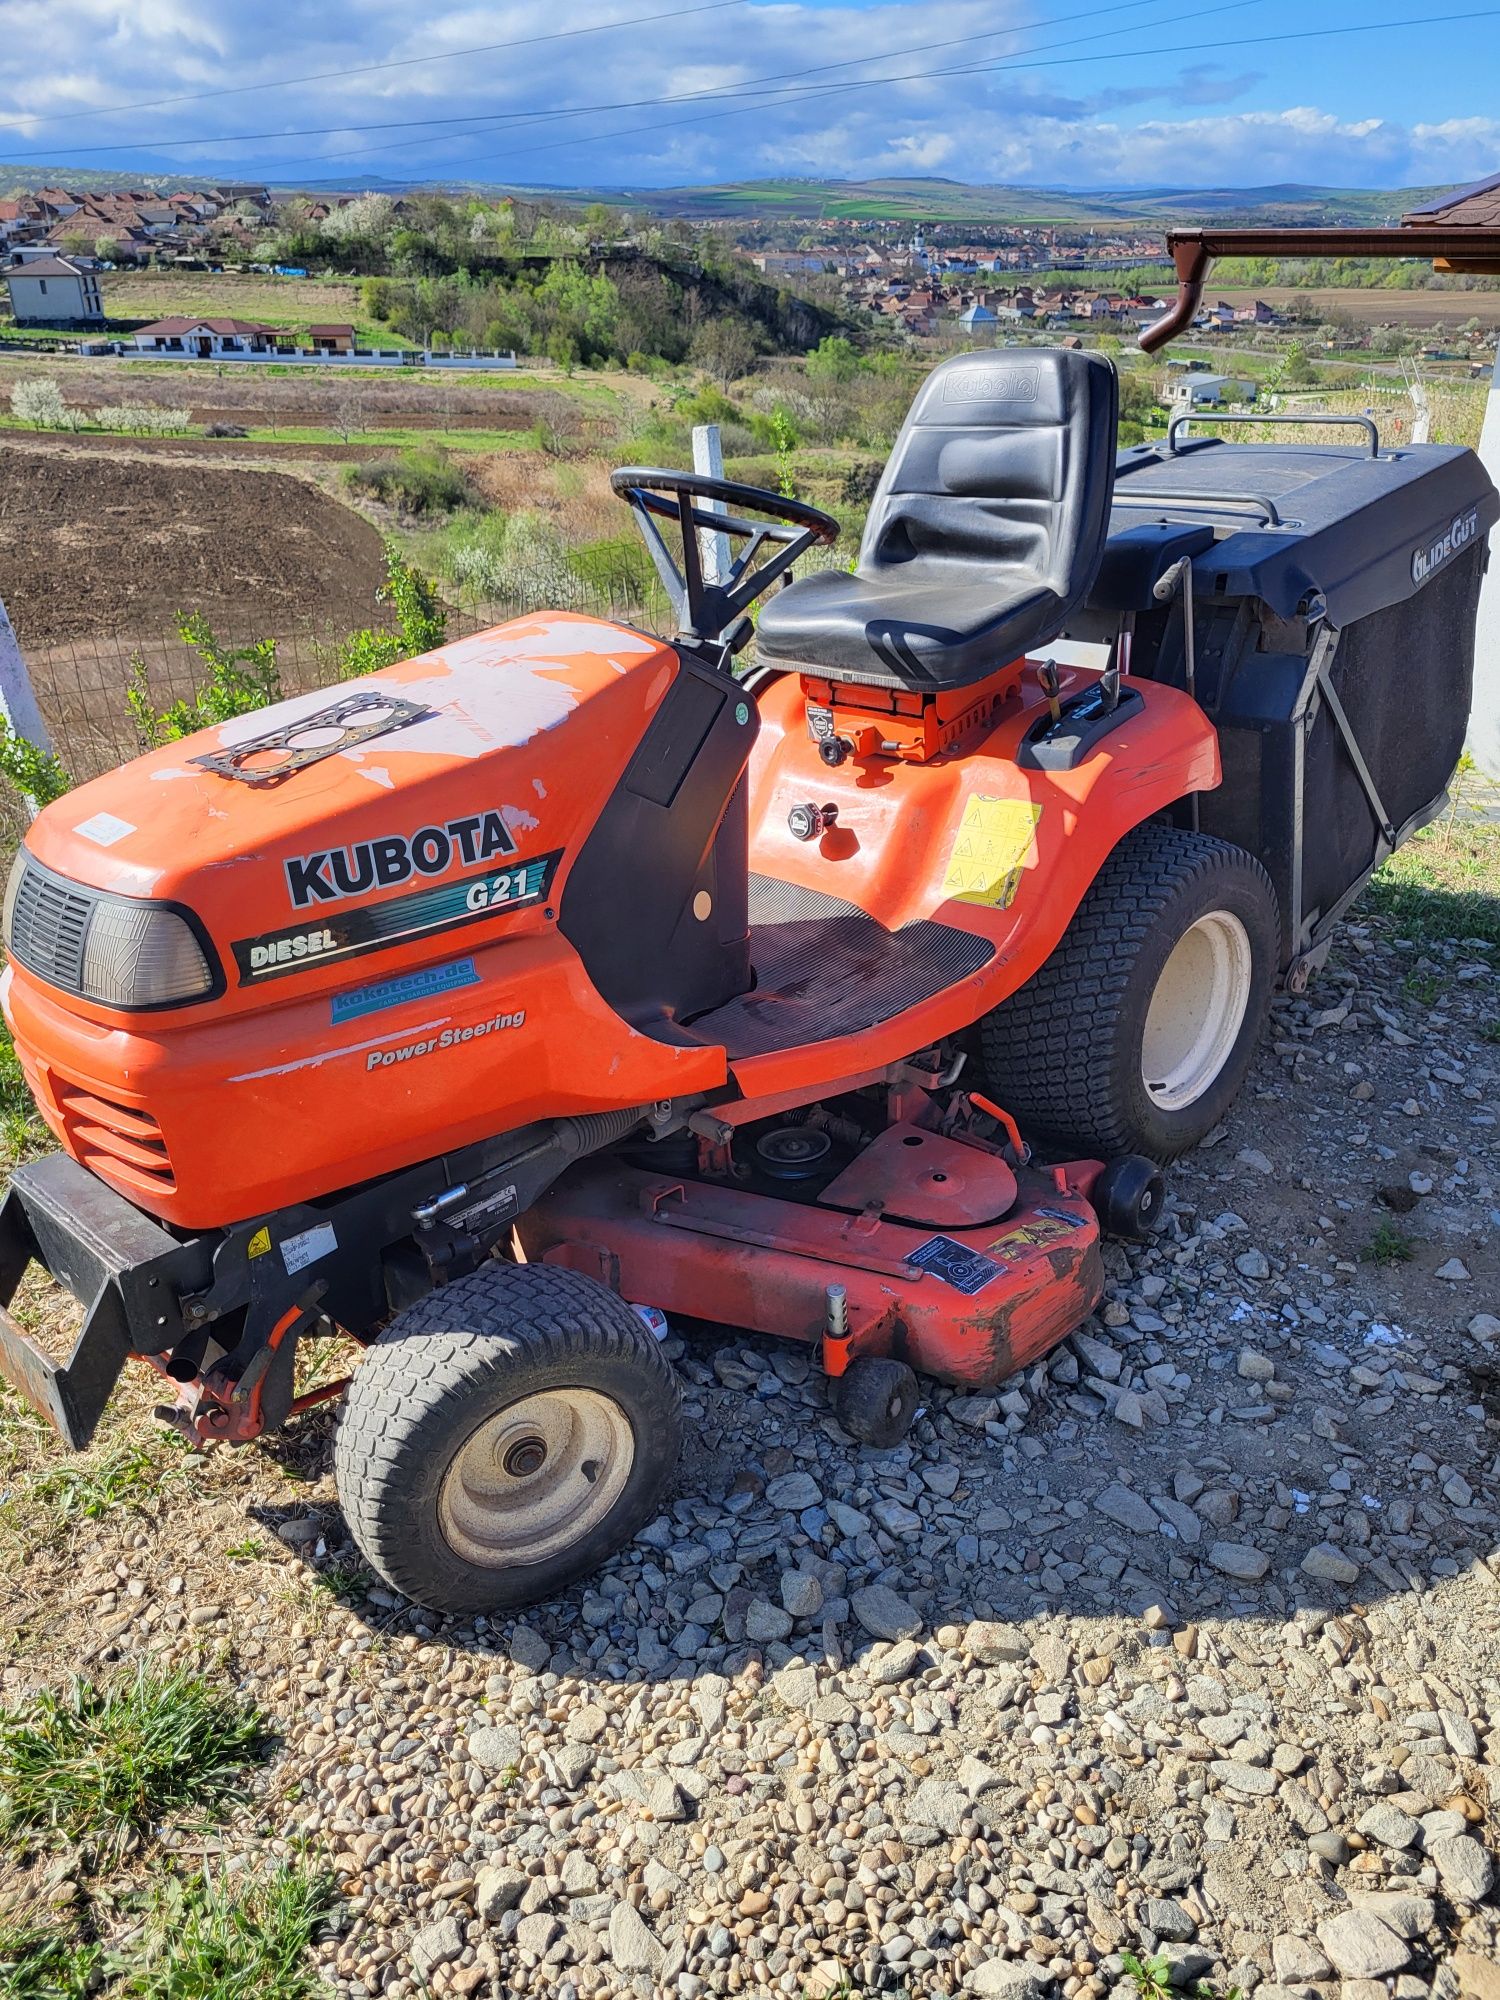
[980,820,1276,1158]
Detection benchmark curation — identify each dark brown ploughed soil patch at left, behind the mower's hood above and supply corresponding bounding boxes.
[0,450,382,648]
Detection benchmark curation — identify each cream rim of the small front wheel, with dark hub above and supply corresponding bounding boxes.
[438,1388,636,1570]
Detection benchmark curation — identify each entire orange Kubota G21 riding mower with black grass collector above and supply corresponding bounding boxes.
[0,227,1500,1612]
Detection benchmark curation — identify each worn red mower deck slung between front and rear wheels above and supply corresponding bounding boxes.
[520,1126,1104,1388]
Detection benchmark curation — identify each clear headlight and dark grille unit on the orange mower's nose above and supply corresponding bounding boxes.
[4,848,218,1010]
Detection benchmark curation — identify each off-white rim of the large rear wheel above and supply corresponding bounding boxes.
[1140,910,1252,1112]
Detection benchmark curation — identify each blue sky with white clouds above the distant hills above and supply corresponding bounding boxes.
[0,0,1500,188]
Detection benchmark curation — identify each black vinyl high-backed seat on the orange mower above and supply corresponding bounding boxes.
[756,348,1118,690]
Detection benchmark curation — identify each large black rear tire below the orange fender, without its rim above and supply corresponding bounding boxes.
[980,824,1280,1162]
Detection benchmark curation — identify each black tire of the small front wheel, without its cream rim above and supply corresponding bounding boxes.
[334,1264,680,1612]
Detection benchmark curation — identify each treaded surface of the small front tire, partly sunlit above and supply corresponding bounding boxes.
[334,1264,680,1604]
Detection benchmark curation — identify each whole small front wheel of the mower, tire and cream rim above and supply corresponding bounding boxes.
[334,1264,678,1612]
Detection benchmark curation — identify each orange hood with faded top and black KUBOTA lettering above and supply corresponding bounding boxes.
[12,612,678,1004]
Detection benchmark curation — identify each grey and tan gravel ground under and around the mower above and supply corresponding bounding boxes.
[0,904,1500,2000]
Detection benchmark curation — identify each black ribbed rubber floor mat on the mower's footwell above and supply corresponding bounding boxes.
[692,874,994,1058]
